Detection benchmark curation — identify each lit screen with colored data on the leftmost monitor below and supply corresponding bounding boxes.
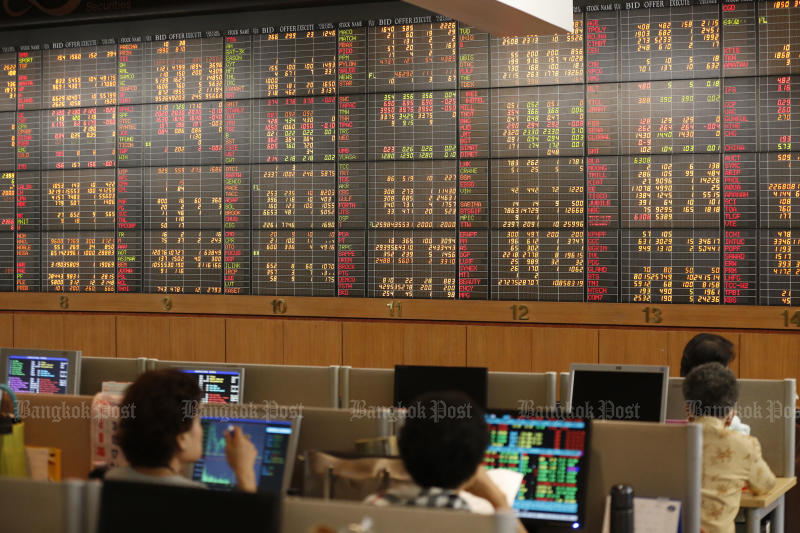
[6,355,69,394]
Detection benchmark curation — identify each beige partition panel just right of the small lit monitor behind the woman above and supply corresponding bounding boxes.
[240,365,340,407]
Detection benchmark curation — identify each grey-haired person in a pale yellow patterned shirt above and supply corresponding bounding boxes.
[683,363,775,533]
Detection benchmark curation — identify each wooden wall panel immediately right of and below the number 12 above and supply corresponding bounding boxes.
[531,327,598,372]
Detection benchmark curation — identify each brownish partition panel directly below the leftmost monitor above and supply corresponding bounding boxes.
[17,394,93,479]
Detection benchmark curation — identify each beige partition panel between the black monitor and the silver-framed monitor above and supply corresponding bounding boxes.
[487,372,556,410]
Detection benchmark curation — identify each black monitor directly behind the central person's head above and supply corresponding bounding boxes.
[394,365,489,410]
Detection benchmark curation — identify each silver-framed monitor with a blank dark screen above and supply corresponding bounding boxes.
[568,363,669,422]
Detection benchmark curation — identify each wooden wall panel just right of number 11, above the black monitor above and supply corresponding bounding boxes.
[403,323,467,366]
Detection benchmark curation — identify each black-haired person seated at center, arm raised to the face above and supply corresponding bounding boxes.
[366,392,525,532]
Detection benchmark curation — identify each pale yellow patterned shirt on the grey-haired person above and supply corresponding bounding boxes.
[695,416,775,533]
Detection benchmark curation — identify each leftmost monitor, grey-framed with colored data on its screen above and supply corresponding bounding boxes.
[0,348,81,394]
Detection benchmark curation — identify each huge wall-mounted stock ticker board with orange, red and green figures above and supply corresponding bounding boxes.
[0,0,800,305]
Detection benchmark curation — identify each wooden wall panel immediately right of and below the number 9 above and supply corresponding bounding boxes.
[169,317,225,363]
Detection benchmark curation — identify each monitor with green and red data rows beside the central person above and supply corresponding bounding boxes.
[484,411,590,531]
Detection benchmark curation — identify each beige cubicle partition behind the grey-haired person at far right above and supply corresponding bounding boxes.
[667,378,797,477]
